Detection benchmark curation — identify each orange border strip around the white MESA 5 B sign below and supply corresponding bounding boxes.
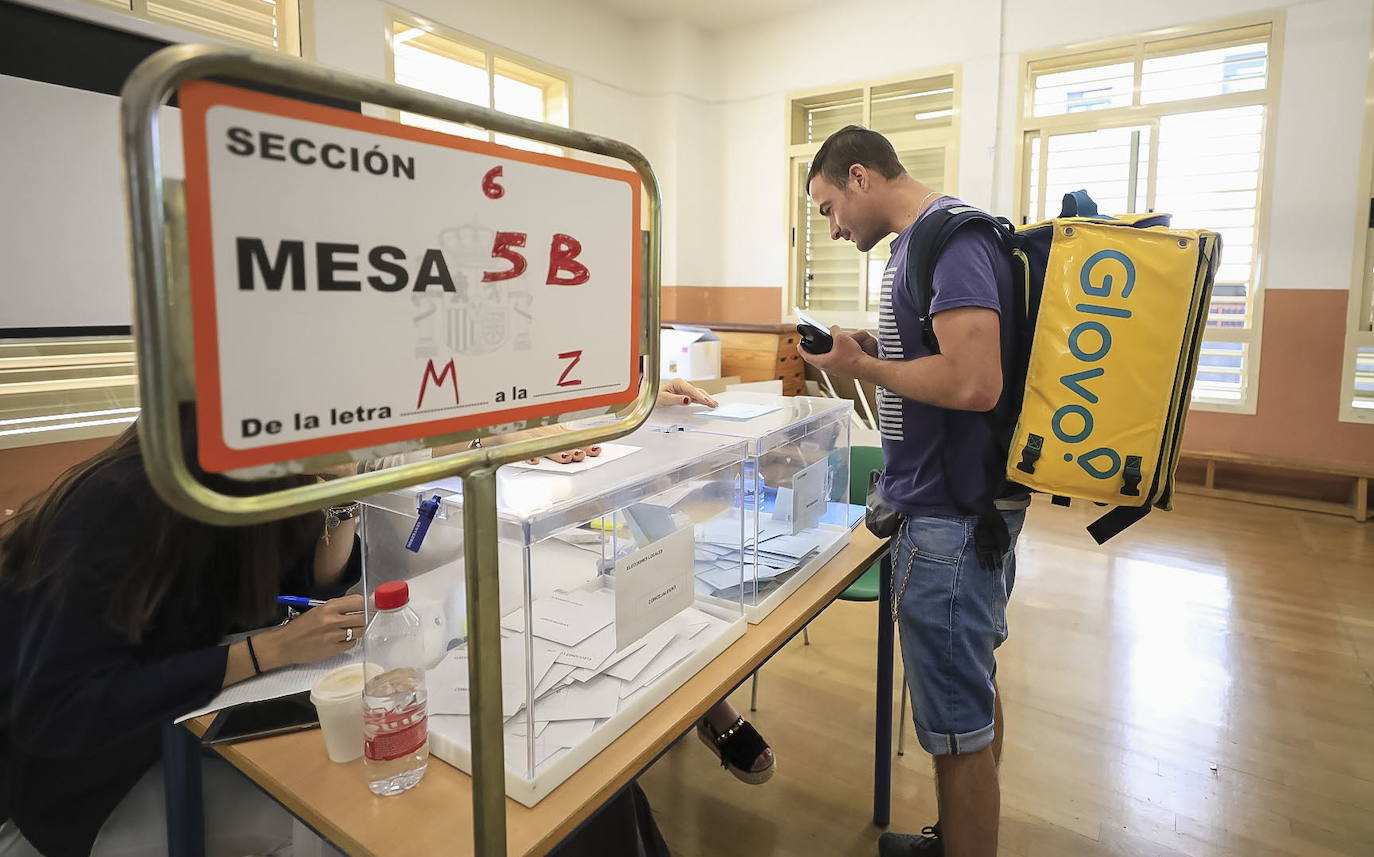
[177,80,643,472]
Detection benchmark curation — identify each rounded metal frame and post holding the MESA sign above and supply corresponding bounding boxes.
[120,45,662,856]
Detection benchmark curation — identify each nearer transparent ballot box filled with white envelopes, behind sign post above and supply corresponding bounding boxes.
[361,431,746,806]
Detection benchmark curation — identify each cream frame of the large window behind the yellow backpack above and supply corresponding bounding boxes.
[1013,10,1285,415]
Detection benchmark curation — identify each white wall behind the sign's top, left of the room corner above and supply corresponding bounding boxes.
[313,0,720,284]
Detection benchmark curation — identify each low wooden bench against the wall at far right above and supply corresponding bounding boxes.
[1178,449,1374,522]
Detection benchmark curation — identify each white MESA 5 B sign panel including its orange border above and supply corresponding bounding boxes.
[180,81,642,471]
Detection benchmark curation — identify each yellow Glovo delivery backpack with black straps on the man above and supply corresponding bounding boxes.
[907,191,1221,546]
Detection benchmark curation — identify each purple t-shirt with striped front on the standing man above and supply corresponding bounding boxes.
[878,196,1013,515]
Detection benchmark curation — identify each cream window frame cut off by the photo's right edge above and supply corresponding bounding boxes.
[1340,19,1374,424]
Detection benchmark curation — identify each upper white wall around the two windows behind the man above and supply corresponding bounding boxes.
[714,0,1371,296]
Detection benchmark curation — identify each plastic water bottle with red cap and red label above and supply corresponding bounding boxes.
[363,581,429,795]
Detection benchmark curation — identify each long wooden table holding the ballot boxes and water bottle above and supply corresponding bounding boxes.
[165,526,892,857]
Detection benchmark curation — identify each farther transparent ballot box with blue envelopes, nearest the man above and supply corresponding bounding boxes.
[640,391,863,622]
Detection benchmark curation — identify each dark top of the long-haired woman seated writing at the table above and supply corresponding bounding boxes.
[0,457,360,857]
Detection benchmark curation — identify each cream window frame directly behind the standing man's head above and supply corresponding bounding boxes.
[782,65,963,328]
